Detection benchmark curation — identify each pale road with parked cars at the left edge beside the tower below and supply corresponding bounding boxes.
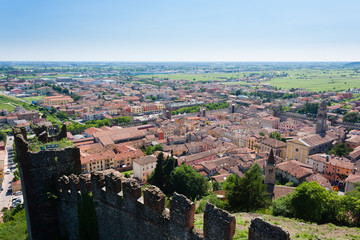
[0,136,16,211]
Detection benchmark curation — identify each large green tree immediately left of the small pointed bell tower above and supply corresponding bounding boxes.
[224,164,270,212]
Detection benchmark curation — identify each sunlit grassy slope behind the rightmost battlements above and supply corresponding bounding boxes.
[195,213,360,240]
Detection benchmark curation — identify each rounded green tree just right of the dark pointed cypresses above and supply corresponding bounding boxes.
[168,164,209,200]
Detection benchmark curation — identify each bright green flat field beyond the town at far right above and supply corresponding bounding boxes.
[268,69,360,92]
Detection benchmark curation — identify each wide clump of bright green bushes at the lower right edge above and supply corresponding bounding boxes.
[273,182,360,227]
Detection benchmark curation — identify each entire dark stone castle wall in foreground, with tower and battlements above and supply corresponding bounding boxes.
[13,128,287,240]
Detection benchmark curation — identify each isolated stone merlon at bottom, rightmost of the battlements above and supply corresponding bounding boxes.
[248,218,290,240]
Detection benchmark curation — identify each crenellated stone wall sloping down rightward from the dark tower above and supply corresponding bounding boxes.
[58,170,235,239]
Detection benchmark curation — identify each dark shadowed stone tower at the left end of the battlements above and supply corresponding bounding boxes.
[13,128,81,239]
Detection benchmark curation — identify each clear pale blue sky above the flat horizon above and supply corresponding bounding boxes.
[0,0,360,62]
